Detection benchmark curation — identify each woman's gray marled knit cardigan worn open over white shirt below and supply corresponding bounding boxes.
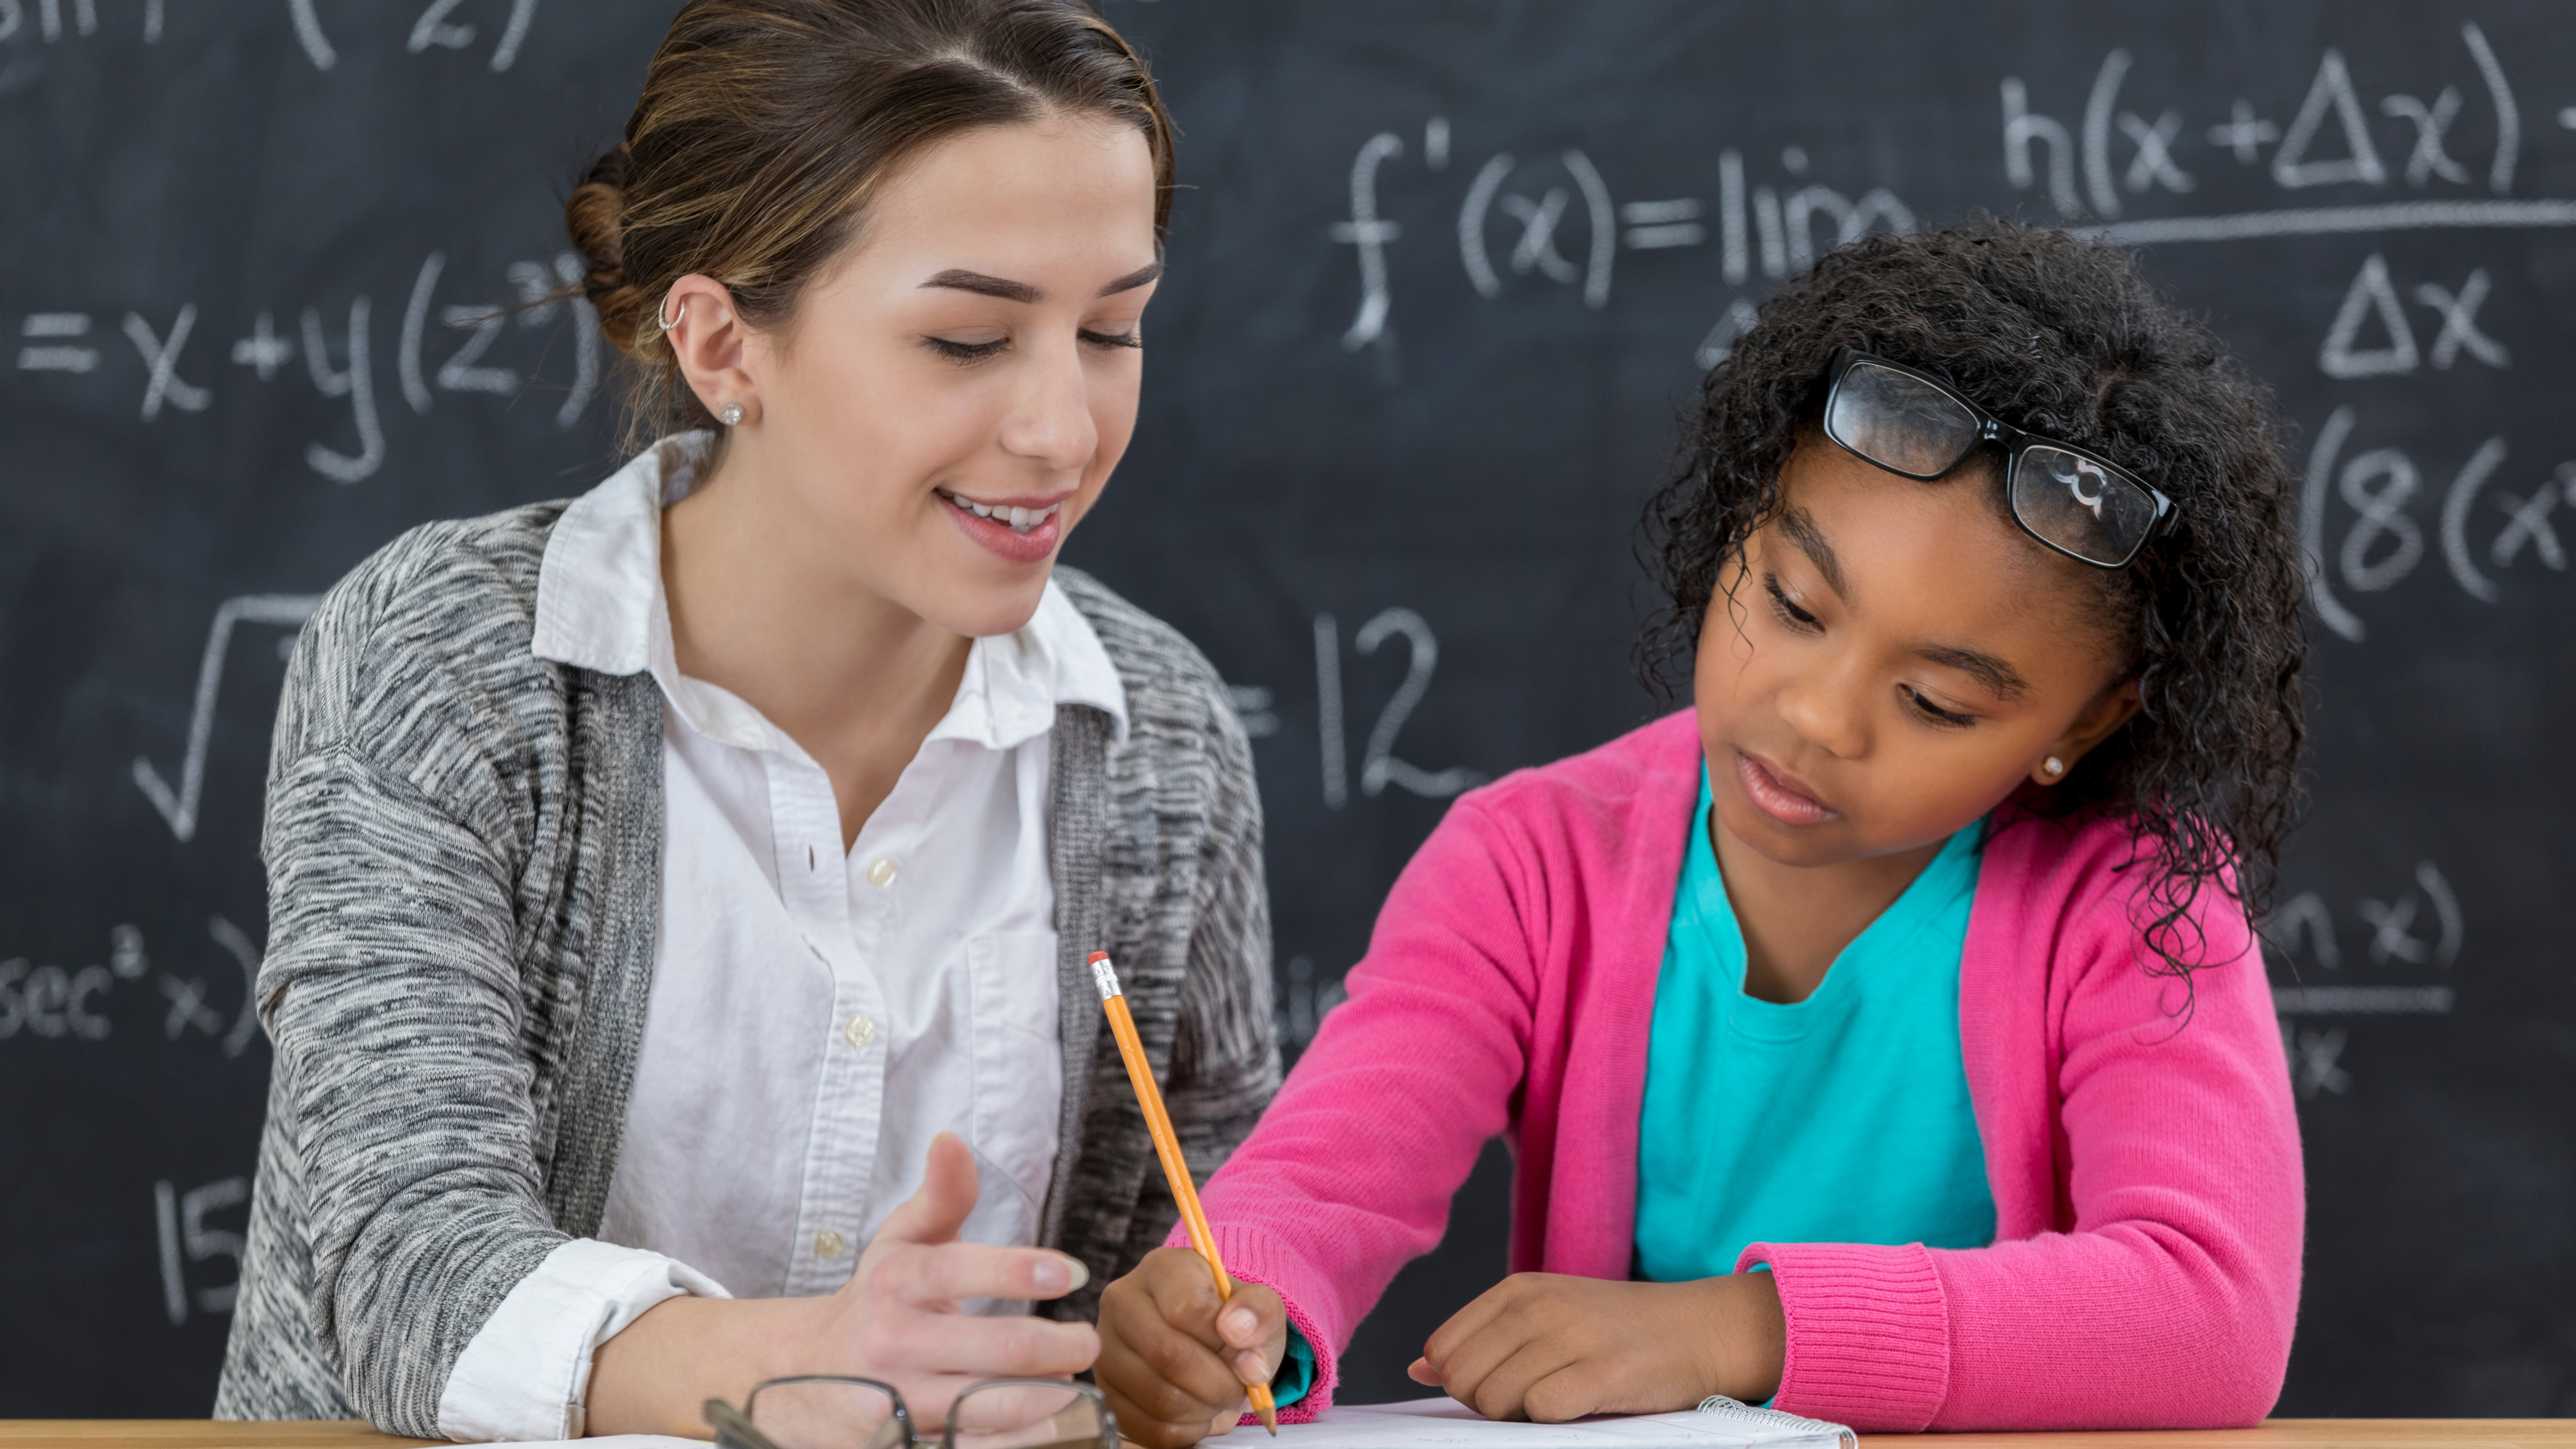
[214,503,1280,1436]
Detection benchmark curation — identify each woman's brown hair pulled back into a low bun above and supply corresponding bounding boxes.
[564,0,1172,444]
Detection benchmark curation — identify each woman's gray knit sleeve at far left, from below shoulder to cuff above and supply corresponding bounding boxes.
[260,745,567,1436]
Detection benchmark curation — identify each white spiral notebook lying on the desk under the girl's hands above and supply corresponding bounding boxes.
[1252,1395,1860,1449]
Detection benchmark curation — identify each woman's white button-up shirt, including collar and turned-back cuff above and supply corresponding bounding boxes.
[438,441,1126,1439]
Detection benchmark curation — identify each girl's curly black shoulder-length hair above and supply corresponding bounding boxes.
[1638,214,2305,1013]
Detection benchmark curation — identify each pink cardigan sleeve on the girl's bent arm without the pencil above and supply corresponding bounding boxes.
[1739,840,2305,1431]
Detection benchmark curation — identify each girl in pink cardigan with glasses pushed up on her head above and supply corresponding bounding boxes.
[1100,219,2303,1446]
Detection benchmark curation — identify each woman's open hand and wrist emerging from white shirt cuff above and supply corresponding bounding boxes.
[587,1132,1102,1436]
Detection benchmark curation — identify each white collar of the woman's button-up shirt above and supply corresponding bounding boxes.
[533,433,1128,753]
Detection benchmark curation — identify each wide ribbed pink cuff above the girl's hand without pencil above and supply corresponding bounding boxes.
[1736,1243,1950,1433]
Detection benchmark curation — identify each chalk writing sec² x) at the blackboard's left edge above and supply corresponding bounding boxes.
[0,915,260,1057]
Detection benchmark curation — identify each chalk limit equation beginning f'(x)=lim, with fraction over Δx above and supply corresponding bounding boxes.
[1324,23,2576,381]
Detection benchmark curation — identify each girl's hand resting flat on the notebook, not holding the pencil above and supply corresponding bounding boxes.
[1401,1271,1788,1423]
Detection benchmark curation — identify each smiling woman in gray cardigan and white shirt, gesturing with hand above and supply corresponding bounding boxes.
[216,0,1278,1449]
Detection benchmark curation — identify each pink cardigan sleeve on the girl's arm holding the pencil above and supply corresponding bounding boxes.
[1172,797,1535,1423]
